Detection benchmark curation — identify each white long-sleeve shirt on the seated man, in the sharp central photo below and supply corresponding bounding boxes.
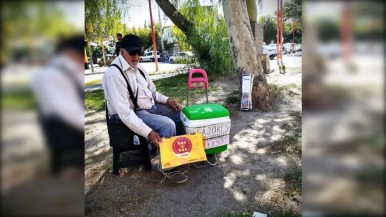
[102,55,168,137]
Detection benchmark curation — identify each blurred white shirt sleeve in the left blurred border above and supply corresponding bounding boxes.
[32,54,84,130]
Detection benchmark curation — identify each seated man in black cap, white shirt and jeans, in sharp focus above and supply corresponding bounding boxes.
[102,34,187,183]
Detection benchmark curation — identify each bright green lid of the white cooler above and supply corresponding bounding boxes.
[182,104,229,120]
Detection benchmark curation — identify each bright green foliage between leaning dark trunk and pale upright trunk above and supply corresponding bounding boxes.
[173,1,234,74]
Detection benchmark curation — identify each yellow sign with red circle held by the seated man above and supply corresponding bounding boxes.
[160,133,206,169]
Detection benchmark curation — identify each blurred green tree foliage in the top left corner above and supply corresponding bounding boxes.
[0,1,78,64]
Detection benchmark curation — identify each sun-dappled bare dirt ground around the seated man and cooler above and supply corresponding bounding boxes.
[85,68,302,216]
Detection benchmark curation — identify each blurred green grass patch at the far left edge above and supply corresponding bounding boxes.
[1,90,37,110]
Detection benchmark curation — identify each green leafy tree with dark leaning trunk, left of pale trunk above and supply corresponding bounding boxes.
[156,0,234,74]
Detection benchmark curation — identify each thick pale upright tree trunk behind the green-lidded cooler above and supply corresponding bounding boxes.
[223,1,272,111]
